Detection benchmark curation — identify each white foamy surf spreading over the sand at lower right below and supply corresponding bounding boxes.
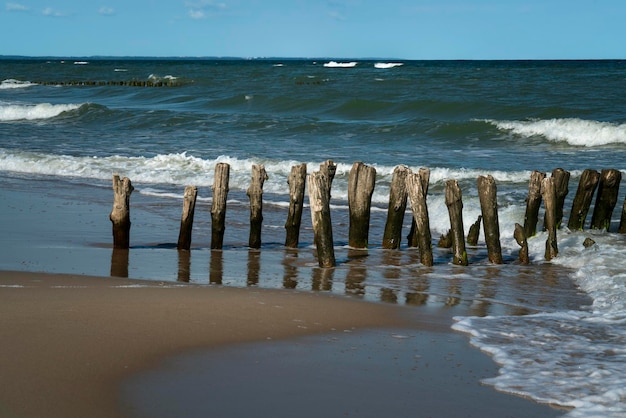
[453,229,626,417]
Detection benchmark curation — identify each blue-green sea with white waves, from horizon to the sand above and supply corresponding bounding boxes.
[0,57,626,417]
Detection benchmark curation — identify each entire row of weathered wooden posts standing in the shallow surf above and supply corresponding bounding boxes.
[110,160,626,267]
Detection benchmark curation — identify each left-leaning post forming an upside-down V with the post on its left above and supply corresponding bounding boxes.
[406,170,434,267]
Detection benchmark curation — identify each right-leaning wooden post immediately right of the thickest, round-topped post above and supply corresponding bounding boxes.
[382,165,411,250]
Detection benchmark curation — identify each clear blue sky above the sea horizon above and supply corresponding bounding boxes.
[0,0,626,59]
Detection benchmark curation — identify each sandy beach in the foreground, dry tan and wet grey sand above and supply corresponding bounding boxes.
[0,271,563,418]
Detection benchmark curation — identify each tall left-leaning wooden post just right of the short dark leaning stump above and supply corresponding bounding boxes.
[477,175,502,264]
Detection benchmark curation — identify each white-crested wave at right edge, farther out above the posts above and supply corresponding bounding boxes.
[485,118,626,147]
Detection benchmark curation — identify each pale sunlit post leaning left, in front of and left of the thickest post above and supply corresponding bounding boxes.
[307,171,336,267]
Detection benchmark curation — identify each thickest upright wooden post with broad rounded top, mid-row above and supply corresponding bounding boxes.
[348,161,376,248]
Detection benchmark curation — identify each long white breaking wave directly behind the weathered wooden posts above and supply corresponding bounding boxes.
[0,149,530,205]
